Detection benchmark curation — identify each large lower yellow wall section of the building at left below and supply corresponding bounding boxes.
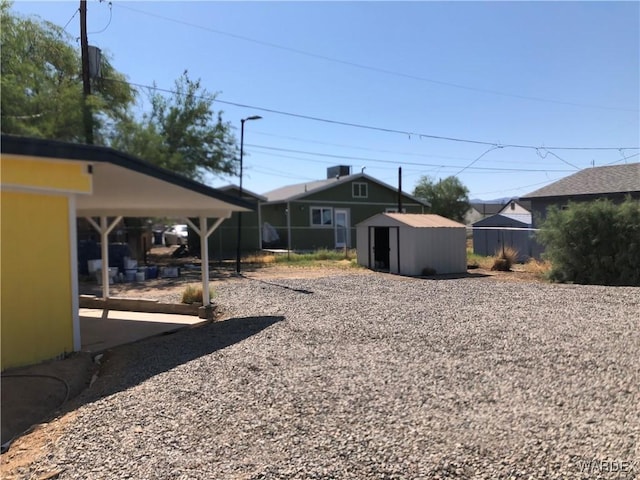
[0,191,73,370]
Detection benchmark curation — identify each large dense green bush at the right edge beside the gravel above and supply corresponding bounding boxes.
[538,197,640,285]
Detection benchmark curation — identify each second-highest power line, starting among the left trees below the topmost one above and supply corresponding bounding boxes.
[104,78,640,151]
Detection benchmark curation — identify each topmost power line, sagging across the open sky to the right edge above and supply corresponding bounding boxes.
[112,5,638,112]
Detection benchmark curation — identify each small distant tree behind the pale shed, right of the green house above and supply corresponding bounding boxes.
[413,176,469,222]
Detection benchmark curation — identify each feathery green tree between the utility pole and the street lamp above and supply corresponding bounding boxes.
[112,71,237,180]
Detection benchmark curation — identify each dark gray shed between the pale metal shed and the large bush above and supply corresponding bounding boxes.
[473,215,532,262]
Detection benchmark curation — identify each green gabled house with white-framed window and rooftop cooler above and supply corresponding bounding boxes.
[260,166,429,250]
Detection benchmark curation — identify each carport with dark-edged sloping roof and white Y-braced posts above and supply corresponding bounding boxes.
[2,135,254,360]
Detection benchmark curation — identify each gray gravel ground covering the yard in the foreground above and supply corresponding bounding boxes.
[25,274,640,479]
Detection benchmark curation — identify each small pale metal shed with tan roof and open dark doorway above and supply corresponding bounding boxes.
[356,213,467,276]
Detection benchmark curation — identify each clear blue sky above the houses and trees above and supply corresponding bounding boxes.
[13,0,640,199]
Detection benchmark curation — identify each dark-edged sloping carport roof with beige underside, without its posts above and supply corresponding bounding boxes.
[0,135,255,218]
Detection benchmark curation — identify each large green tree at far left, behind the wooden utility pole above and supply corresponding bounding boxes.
[0,1,135,143]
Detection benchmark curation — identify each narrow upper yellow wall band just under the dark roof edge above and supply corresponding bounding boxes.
[0,154,92,193]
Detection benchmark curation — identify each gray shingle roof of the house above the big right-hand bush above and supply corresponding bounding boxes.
[520,163,640,199]
